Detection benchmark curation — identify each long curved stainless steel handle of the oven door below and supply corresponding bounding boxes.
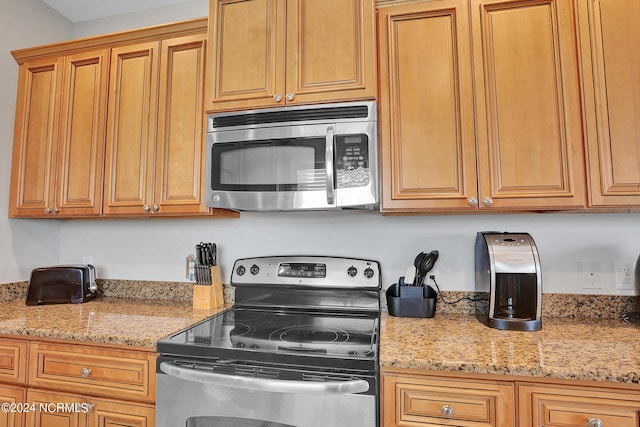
[160,362,369,394]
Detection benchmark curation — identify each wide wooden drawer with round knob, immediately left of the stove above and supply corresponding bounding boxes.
[29,342,155,402]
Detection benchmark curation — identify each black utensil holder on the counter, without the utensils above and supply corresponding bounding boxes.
[387,283,438,317]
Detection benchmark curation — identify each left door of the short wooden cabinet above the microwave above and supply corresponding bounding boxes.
[205,0,286,111]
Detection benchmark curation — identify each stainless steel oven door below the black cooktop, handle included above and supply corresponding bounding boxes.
[156,361,378,427]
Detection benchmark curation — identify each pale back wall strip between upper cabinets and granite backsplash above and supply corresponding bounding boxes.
[61,211,640,295]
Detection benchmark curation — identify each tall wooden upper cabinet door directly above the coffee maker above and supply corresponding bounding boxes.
[471,0,585,209]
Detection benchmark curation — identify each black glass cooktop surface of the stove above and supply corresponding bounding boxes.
[157,308,379,367]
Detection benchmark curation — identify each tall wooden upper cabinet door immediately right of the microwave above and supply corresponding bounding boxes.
[378,0,477,212]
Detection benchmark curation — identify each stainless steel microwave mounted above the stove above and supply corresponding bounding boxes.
[205,102,379,211]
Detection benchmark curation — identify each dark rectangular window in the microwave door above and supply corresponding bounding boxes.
[211,138,326,191]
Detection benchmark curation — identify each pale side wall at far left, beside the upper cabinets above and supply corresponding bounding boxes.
[0,0,73,283]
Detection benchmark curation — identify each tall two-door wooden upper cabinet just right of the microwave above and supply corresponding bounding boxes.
[378,0,586,212]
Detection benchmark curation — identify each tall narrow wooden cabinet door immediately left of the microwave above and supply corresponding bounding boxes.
[152,34,208,215]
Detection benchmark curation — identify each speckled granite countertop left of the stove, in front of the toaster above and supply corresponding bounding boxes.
[0,297,230,351]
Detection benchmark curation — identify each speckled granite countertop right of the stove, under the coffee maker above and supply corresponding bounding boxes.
[380,313,640,384]
